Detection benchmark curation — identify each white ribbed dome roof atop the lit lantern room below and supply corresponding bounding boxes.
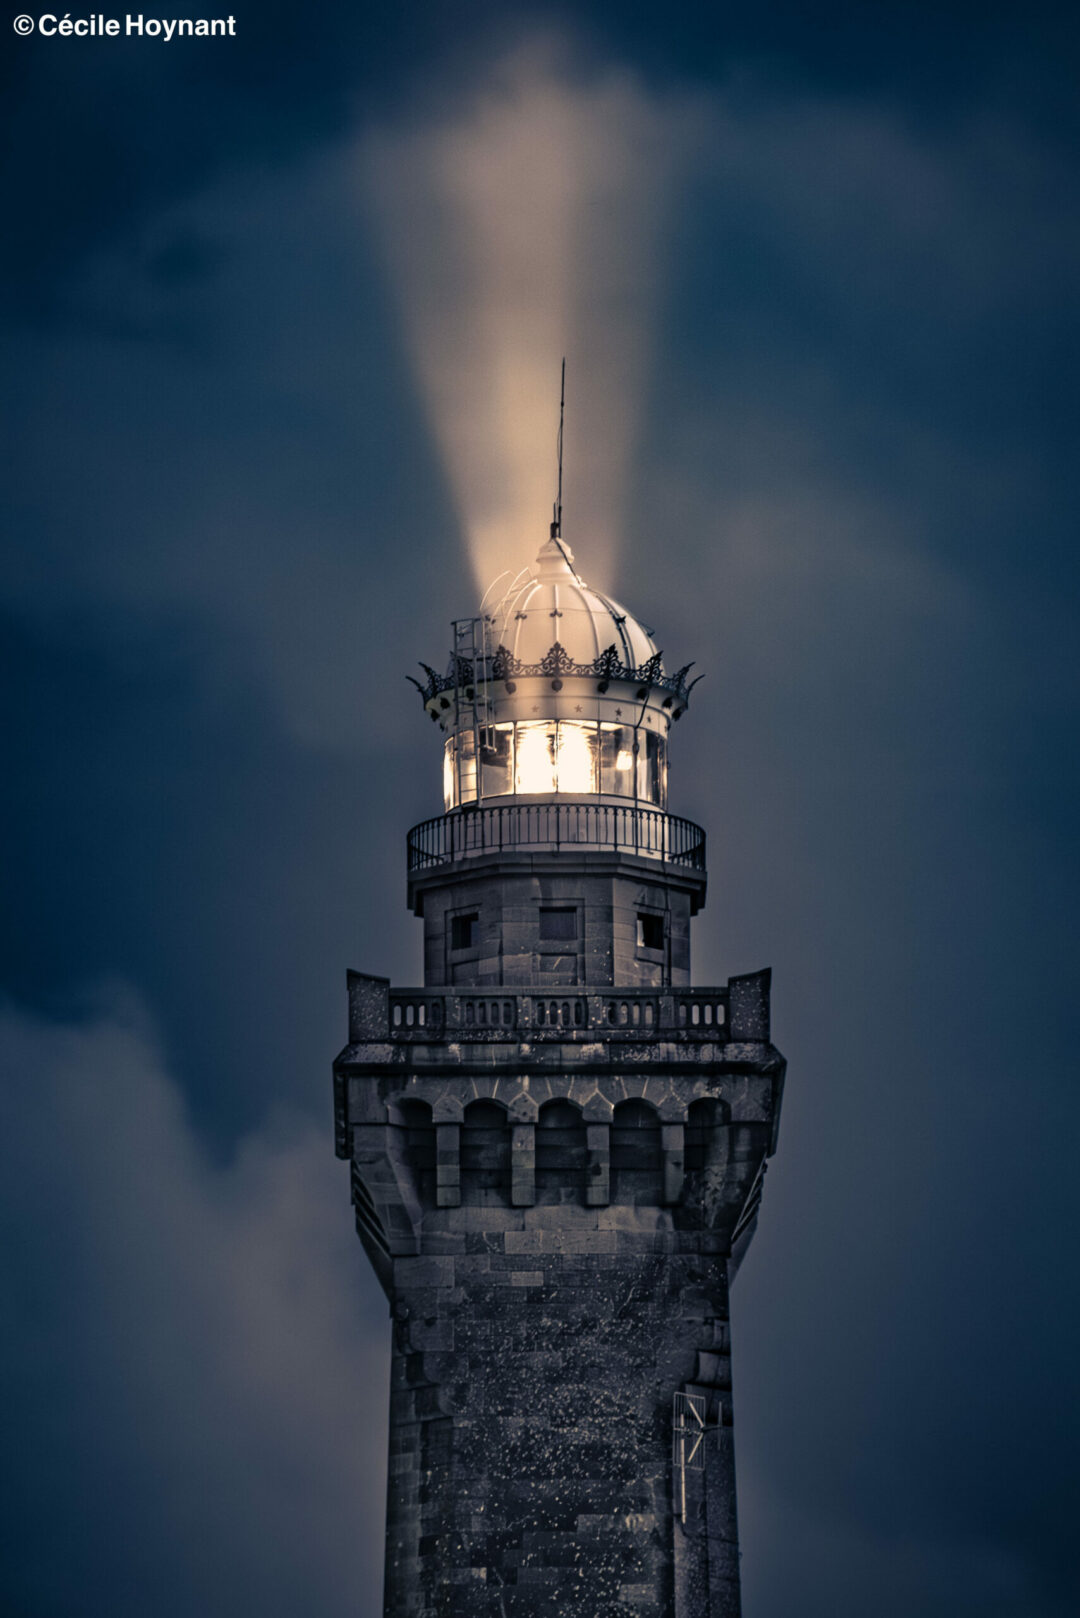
[491,539,656,668]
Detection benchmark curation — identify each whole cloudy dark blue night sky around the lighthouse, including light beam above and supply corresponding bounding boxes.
[0,0,1080,1618]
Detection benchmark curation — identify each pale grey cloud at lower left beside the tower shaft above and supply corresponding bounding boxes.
[0,1006,389,1618]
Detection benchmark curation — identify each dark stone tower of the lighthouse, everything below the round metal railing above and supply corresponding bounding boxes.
[335,828,784,1618]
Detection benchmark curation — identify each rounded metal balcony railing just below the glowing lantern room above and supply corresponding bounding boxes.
[408,803,704,875]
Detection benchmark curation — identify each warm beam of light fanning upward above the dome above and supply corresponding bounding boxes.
[363,42,696,592]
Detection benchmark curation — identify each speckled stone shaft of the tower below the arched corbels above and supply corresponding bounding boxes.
[385,1205,738,1618]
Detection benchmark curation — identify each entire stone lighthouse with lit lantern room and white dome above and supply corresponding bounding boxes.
[334,523,784,1618]
